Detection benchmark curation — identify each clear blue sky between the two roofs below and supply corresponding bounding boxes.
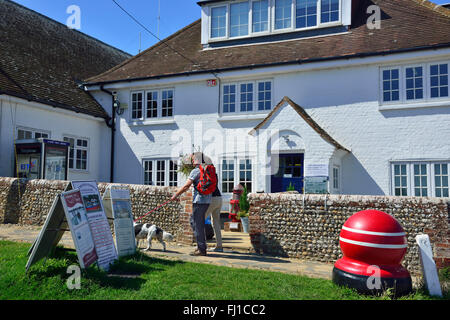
[9,0,450,55]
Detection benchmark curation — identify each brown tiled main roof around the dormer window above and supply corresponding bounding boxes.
[86,0,450,84]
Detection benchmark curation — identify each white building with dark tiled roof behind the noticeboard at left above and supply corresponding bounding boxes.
[0,0,130,181]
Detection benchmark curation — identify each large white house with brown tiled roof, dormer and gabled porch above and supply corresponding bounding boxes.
[81,0,450,204]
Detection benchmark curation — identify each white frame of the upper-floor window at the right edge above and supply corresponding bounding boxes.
[378,60,450,110]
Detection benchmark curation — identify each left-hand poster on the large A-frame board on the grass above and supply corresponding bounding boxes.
[61,189,98,269]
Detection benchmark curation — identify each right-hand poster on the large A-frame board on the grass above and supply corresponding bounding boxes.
[72,181,117,270]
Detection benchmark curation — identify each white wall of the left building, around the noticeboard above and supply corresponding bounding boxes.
[0,95,111,182]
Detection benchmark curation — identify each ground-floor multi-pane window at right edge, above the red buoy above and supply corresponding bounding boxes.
[392,161,450,197]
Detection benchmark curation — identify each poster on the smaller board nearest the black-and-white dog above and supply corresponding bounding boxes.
[103,186,136,257]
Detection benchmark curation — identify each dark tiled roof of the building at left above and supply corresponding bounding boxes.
[0,0,131,119]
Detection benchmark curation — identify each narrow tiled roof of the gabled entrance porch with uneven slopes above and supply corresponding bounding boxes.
[249,97,350,152]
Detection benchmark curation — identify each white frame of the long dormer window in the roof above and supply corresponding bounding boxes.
[207,0,344,43]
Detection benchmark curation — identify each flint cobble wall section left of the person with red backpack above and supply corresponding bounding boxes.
[0,178,193,243]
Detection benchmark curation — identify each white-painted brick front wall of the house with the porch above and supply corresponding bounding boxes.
[89,51,450,195]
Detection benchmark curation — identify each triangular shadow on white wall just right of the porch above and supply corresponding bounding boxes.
[342,153,387,195]
